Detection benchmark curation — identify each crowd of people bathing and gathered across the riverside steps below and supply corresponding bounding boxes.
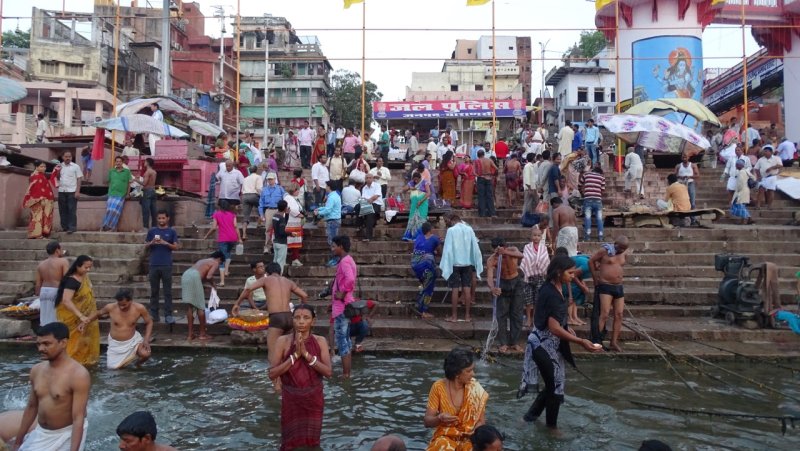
[12,118,783,450]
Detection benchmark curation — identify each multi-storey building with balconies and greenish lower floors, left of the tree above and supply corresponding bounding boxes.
[234,14,331,139]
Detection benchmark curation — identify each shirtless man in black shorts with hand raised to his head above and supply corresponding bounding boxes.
[589,236,628,352]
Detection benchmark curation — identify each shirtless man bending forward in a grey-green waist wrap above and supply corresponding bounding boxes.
[181,251,225,341]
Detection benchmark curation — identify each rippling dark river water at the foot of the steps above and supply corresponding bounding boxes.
[0,345,800,451]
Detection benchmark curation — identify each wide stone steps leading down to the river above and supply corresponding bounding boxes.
[0,162,800,341]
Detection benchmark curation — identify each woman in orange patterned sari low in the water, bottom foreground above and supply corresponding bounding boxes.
[423,348,489,451]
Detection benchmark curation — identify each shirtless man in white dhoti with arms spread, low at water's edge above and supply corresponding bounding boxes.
[78,288,153,370]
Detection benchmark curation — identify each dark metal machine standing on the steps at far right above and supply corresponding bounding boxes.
[711,254,769,328]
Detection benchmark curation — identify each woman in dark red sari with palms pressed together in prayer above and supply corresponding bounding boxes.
[269,304,333,451]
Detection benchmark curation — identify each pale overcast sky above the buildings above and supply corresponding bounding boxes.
[15,0,758,100]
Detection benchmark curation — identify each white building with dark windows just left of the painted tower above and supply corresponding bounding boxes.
[545,47,617,127]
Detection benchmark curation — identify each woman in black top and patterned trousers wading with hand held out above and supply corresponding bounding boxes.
[519,255,602,429]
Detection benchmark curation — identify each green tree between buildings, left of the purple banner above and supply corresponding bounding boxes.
[330,69,383,128]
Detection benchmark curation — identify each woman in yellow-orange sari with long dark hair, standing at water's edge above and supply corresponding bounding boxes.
[56,255,100,366]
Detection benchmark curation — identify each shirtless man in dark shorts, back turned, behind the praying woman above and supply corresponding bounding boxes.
[231,262,308,390]
